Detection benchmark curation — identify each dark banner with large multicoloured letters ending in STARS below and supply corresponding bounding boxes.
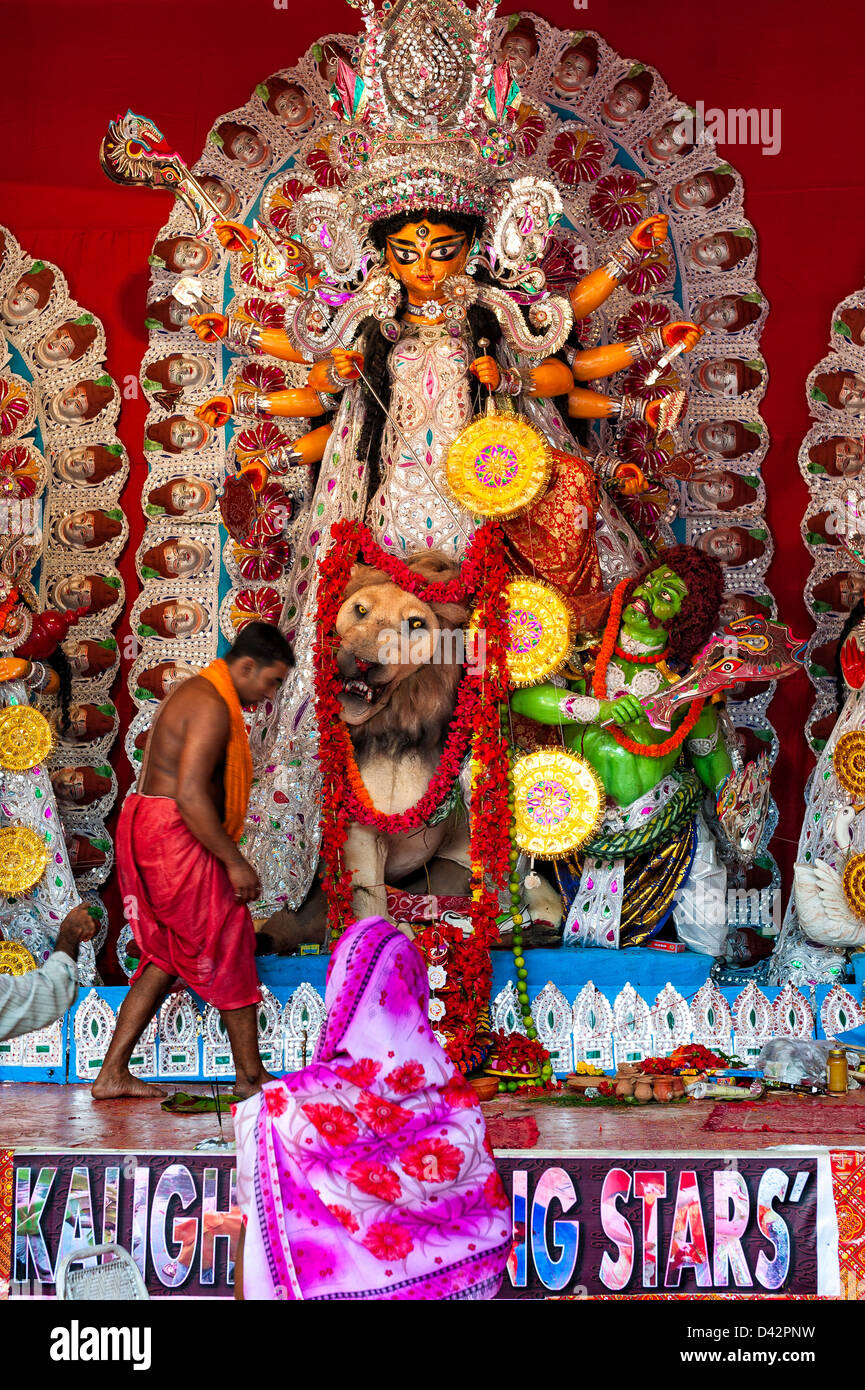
[0,1152,845,1300]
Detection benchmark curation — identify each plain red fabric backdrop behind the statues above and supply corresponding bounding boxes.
[0,0,865,965]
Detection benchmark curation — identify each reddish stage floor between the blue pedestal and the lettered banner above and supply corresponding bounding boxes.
[6,1081,865,1156]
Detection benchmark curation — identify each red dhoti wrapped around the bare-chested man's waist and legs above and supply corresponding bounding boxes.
[117,792,259,1009]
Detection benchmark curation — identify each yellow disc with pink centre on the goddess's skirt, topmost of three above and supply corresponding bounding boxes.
[448,416,552,517]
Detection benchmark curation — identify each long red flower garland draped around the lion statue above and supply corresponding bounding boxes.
[314,521,510,967]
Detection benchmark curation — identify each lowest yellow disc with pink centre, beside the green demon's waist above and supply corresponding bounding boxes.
[513,748,606,859]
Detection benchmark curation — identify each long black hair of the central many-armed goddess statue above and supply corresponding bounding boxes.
[357,209,584,498]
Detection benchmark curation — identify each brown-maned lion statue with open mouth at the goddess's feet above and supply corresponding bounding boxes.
[259,550,470,952]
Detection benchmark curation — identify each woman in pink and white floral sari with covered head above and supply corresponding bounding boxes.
[234,917,512,1300]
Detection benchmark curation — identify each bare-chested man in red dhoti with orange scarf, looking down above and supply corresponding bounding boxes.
[93,623,293,1101]
